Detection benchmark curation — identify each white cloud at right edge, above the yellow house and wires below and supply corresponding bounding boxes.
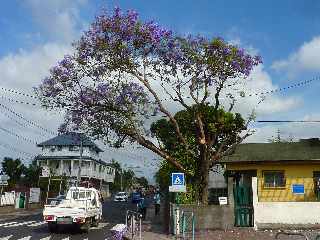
[272,36,320,75]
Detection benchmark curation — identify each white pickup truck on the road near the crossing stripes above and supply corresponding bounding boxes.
[43,187,102,232]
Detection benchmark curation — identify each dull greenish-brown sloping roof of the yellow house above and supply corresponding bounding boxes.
[220,138,320,163]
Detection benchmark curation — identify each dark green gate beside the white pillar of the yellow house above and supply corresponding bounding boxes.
[233,185,253,227]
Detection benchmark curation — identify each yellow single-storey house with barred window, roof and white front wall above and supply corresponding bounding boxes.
[221,138,320,227]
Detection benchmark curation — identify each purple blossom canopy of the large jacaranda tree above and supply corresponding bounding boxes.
[38,5,262,137]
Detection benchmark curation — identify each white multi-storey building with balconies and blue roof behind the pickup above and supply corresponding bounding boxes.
[36,133,115,195]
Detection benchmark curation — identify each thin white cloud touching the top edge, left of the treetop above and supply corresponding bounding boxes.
[25,0,87,43]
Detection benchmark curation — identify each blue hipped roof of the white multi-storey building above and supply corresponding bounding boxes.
[37,132,103,152]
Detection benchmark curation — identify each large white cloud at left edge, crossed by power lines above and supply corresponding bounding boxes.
[0,43,71,164]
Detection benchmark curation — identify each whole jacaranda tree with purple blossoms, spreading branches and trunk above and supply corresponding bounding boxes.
[36,8,261,203]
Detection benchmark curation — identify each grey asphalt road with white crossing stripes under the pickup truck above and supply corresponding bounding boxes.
[0,200,136,240]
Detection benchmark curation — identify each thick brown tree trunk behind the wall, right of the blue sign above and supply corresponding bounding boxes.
[198,144,209,205]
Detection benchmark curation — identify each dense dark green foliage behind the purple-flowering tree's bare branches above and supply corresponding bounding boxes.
[151,104,245,203]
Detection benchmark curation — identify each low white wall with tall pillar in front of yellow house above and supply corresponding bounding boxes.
[252,177,320,229]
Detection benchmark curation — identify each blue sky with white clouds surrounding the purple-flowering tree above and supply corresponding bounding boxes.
[0,0,320,182]
